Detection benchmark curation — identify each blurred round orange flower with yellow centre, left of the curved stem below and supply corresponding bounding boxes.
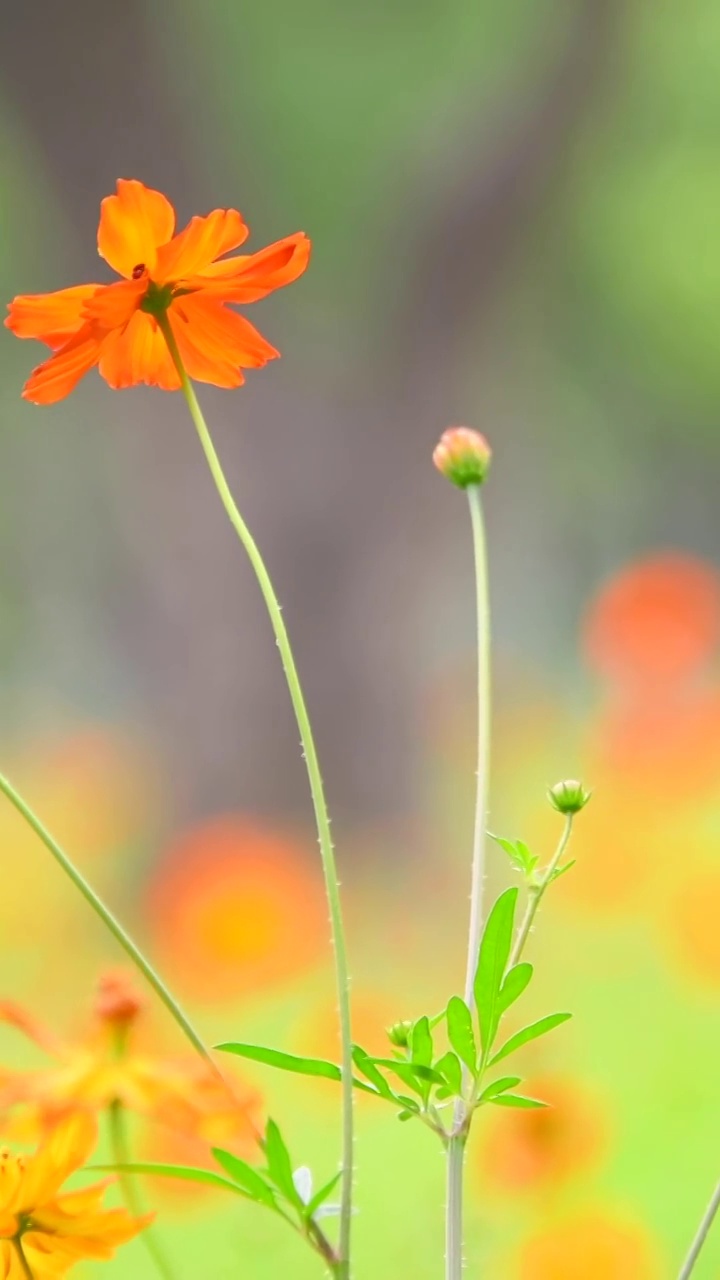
[149,817,328,1001]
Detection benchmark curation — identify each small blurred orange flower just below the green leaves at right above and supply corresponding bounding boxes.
[480,1076,607,1192]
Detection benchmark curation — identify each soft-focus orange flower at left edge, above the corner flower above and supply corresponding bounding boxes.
[0,974,258,1143]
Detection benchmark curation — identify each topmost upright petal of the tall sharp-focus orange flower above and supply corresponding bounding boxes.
[97,178,176,278]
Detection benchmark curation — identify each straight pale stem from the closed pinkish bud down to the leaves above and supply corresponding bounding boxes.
[465,485,491,1009]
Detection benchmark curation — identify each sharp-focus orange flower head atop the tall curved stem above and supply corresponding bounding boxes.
[5,178,310,404]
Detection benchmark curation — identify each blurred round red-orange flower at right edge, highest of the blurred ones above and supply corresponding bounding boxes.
[584,552,720,689]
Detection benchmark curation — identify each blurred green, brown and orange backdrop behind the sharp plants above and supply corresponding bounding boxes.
[0,0,720,1280]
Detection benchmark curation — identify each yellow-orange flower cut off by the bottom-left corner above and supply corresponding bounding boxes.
[0,1114,146,1280]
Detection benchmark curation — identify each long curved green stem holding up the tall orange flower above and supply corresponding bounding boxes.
[158,316,355,1280]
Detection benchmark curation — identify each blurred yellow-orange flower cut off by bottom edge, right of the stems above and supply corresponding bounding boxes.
[519,1211,661,1280]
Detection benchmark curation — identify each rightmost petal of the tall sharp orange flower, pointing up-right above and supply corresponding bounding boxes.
[187,232,311,302]
